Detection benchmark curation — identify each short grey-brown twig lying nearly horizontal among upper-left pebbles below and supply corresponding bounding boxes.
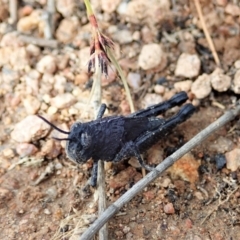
[18,34,58,48]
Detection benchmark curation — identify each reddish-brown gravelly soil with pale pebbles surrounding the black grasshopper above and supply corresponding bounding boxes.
[0,0,240,240]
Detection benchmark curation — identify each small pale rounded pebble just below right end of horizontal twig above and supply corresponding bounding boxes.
[36,55,57,74]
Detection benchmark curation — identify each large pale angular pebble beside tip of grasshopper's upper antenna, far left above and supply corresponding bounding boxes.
[11,115,51,143]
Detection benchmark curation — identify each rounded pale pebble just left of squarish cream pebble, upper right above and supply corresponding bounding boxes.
[138,43,166,71]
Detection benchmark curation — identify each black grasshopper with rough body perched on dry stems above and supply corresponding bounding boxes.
[39,92,195,186]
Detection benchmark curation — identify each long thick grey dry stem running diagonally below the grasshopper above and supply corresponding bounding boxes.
[79,105,240,240]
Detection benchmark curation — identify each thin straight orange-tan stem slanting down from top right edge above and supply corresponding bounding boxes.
[194,0,220,66]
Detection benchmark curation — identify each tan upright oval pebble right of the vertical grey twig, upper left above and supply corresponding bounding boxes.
[56,18,79,44]
